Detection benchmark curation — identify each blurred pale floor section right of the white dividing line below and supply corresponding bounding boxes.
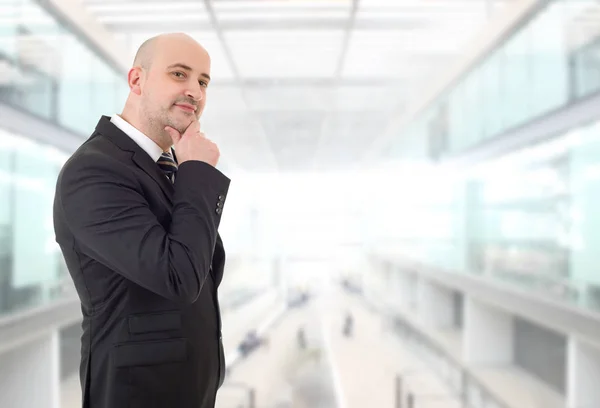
[323,291,460,408]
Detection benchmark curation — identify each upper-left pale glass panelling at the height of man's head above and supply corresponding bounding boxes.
[0,0,128,135]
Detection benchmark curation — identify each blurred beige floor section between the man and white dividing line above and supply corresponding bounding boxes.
[217,303,335,408]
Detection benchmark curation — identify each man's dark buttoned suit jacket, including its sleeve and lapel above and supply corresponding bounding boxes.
[54,116,230,408]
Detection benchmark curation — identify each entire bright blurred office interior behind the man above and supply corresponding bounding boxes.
[0,0,600,408]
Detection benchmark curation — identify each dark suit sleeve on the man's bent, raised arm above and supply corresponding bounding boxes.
[59,157,230,303]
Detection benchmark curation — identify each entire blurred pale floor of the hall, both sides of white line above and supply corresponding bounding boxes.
[62,290,459,408]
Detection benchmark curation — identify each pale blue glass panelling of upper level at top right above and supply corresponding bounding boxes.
[390,0,600,158]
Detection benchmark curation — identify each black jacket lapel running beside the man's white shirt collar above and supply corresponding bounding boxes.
[96,116,175,205]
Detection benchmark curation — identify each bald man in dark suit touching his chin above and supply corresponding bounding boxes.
[54,34,230,408]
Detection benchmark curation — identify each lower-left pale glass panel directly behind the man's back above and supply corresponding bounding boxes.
[0,127,66,314]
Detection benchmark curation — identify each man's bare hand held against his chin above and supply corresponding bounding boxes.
[165,120,221,167]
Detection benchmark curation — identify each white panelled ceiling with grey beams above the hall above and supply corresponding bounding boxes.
[81,0,518,172]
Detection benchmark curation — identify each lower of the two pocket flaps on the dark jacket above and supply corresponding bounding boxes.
[112,339,187,367]
